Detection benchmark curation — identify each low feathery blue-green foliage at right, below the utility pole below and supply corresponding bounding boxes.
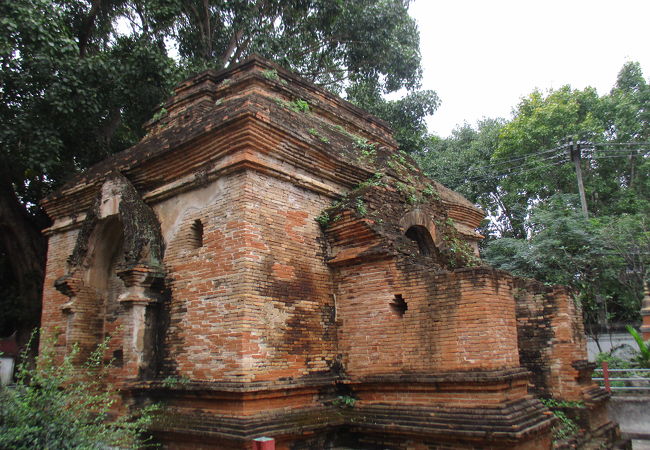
[483,195,650,333]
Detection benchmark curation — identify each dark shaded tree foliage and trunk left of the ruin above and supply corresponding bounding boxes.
[0,0,177,336]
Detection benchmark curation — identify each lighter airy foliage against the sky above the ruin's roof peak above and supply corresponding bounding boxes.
[170,0,421,92]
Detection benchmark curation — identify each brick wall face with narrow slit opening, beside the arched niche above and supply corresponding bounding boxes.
[161,174,252,380]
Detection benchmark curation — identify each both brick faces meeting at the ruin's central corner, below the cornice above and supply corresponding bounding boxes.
[157,171,335,381]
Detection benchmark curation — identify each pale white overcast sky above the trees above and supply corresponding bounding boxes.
[409,0,650,137]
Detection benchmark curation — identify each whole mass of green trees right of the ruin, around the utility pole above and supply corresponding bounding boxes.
[418,63,650,332]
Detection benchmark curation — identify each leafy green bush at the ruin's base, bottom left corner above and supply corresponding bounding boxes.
[0,332,156,449]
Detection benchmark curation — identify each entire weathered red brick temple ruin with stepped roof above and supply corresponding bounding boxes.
[42,57,617,449]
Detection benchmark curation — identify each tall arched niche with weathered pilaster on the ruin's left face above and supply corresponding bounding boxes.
[55,174,165,378]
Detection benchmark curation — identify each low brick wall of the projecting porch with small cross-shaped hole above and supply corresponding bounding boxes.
[337,259,519,376]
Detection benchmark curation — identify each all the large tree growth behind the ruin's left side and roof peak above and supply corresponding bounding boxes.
[0,0,437,340]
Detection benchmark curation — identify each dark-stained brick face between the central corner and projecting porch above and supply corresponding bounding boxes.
[235,172,336,380]
